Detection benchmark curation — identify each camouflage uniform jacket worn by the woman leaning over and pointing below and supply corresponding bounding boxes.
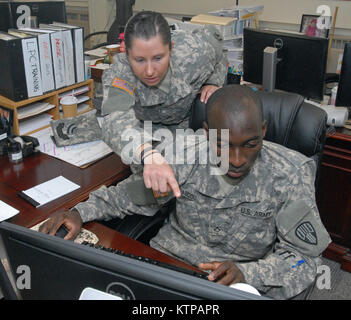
[102,27,227,159]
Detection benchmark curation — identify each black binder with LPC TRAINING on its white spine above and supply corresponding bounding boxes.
[0,32,43,101]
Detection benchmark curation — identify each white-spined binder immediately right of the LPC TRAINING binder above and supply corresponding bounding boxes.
[19,28,55,93]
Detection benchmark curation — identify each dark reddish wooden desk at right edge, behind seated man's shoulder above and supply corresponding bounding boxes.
[316,128,351,272]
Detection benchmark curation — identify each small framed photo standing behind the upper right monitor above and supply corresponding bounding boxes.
[300,14,332,38]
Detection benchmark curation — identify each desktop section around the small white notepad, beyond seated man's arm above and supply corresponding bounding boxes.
[0,153,130,227]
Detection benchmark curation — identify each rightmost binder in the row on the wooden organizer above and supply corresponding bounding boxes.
[52,21,85,82]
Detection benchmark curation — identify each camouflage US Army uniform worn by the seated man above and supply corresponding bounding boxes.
[76,141,330,299]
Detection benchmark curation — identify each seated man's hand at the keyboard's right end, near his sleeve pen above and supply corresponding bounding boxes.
[198,260,245,286]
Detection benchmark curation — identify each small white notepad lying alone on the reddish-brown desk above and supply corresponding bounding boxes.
[22,176,80,206]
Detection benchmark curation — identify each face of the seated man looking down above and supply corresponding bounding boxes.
[211,111,266,180]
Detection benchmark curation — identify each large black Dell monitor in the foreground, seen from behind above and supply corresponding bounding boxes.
[0,222,264,300]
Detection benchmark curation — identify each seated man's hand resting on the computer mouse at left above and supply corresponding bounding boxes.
[39,210,83,240]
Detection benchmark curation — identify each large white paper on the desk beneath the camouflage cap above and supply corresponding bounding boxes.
[31,127,113,167]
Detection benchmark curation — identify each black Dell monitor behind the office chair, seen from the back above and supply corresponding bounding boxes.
[243,28,328,100]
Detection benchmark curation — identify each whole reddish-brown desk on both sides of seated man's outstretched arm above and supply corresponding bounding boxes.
[0,153,201,272]
